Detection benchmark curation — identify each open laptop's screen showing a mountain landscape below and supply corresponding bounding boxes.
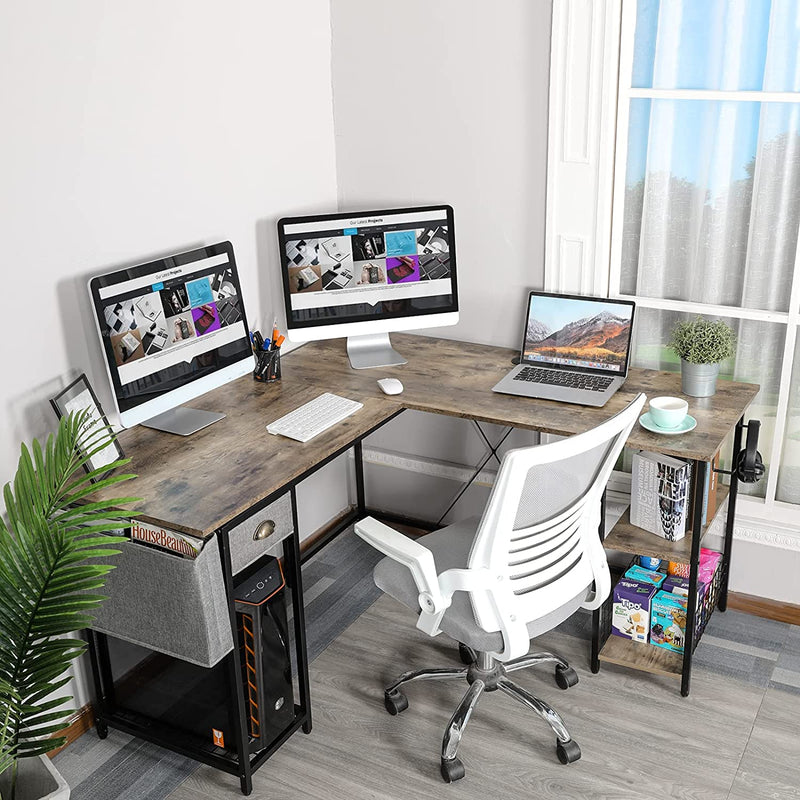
[522,292,634,375]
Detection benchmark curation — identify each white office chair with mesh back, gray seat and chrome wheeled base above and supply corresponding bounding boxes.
[355,394,646,783]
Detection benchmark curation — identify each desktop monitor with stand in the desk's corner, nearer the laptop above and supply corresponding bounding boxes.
[278,205,458,369]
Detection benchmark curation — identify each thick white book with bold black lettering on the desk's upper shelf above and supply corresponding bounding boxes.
[630,452,692,542]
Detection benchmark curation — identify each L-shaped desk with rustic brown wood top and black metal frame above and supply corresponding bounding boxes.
[88,334,758,794]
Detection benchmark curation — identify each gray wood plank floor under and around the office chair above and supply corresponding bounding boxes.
[164,597,800,800]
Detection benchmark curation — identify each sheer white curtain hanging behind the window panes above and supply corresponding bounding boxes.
[621,0,800,501]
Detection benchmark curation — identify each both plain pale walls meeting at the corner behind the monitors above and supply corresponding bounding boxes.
[0,0,550,704]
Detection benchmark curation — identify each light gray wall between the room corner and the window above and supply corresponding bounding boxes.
[331,0,552,519]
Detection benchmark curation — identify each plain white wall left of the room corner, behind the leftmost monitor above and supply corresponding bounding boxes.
[0,0,337,703]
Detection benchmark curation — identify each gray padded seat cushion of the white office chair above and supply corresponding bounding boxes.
[373,517,591,653]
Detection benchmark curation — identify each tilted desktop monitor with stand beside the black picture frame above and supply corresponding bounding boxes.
[89,242,253,435]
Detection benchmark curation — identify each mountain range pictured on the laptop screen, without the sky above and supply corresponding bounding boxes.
[525,311,631,365]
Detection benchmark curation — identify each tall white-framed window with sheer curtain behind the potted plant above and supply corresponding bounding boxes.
[609,0,800,525]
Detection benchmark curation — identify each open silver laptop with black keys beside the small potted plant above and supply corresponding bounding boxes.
[492,292,635,406]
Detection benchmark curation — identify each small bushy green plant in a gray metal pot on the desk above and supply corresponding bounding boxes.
[669,317,736,397]
